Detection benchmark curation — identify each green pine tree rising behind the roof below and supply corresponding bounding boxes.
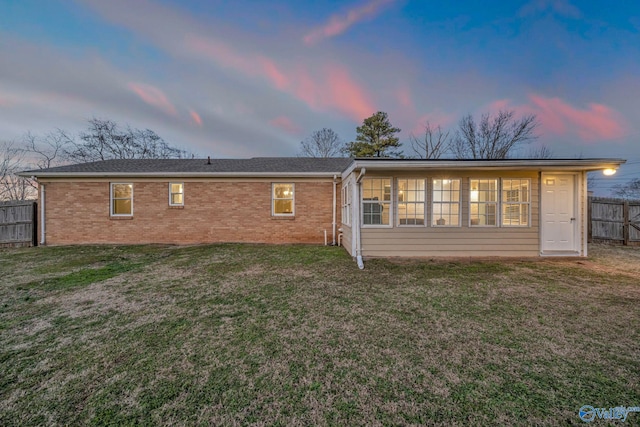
[347,111,402,157]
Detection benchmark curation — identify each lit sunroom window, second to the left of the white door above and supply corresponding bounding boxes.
[469,179,498,227]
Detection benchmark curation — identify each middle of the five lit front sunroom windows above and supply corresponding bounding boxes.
[431,178,461,227]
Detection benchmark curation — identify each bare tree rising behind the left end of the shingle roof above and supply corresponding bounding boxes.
[65,118,189,163]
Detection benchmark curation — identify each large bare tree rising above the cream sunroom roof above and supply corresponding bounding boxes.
[452,111,538,159]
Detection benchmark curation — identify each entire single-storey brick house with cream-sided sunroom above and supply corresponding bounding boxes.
[20,157,625,257]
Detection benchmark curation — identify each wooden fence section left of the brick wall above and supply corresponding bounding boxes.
[0,200,38,247]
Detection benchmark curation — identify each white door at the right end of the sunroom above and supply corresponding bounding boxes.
[540,174,578,252]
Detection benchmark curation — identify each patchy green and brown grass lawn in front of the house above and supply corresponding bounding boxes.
[0,245,640,426]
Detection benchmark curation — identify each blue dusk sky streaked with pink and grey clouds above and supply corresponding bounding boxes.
[0,0,640,194]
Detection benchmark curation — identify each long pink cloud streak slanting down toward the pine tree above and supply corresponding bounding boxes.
[186,36,375,121]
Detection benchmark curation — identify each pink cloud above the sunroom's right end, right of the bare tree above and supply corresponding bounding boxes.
[529,94,627,141]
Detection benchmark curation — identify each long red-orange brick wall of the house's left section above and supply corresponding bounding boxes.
[39,180,340,245]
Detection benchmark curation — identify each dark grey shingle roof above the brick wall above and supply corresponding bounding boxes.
[21,157,351,176]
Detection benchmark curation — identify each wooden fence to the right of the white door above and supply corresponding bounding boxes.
[589,197,640,246]
